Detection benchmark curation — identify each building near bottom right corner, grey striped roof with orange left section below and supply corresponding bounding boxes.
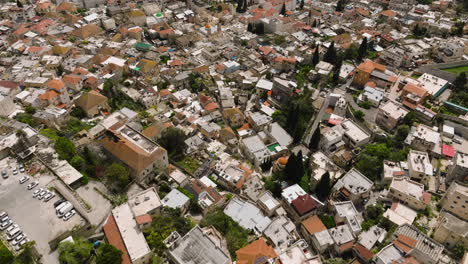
[394,225,444,264]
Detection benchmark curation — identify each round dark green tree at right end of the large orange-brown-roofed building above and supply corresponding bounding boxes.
[159,127,187,158]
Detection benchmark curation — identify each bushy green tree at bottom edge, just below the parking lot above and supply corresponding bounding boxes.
[58,238,93,264]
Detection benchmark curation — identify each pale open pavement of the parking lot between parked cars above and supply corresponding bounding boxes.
[0,158,85,264]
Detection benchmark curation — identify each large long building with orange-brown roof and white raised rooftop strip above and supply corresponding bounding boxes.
[99,122,169,181]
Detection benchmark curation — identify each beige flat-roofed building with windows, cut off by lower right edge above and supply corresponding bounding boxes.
[440,181,468,221]
